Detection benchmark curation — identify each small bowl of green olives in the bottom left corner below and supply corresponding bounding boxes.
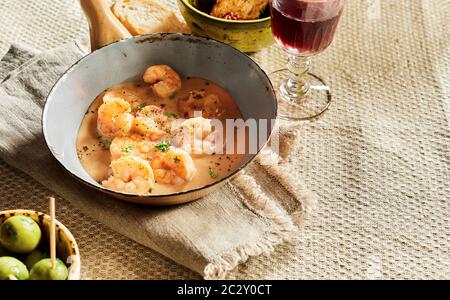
[0,210,81,280]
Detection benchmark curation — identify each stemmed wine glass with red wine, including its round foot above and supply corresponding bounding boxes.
[270,0,344,120]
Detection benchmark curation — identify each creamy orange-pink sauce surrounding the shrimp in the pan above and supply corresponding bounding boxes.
[77,77,243,195]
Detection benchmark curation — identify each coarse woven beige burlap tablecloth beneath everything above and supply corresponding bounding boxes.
[0,0,450,279]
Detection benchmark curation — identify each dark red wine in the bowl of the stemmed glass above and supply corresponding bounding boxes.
[270,0,343,54]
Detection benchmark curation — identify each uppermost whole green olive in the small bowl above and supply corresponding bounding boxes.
[0,216,42,253]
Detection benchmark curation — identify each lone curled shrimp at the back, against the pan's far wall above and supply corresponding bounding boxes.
[144,65,181,98]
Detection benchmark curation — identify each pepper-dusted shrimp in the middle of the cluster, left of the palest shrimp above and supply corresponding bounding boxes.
[133,105,170,141]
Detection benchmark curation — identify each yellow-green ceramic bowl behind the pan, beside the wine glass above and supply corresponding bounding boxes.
[178,0,274,52]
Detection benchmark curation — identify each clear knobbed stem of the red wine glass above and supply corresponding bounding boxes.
[286,54,312,97]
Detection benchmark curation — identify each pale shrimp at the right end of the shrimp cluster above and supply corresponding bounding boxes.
[172,117,218,154]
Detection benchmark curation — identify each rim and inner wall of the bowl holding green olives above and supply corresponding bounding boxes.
[0,209,81,280]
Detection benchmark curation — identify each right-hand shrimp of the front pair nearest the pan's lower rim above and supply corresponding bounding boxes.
[150,147,197,185]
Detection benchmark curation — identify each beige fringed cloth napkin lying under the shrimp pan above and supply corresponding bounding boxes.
[0,43,315,278]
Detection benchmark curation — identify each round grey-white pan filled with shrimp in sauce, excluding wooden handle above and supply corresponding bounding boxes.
[42,34,277,205]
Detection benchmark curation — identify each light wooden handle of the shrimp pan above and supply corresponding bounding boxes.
[80,0,131,51]
